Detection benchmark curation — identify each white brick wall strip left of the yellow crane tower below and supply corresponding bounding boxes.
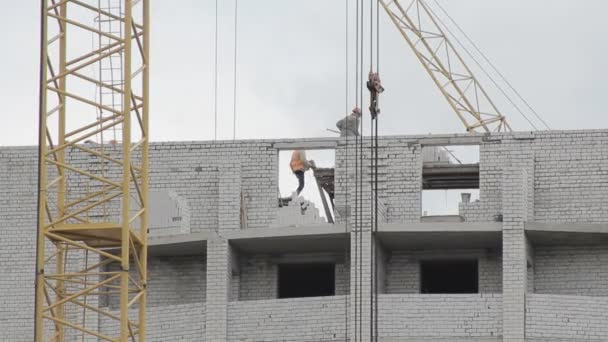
[0,147,37,342]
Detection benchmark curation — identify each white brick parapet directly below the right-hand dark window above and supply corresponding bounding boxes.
[378,294,502,340]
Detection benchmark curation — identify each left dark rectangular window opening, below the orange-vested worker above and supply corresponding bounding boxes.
[279,264,336,298]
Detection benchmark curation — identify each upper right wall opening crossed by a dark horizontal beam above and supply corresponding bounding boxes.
[421,145,479,221]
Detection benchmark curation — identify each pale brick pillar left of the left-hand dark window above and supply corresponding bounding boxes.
[205,235,231,342]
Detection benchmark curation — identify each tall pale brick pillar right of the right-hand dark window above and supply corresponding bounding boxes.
[502,167,530,342]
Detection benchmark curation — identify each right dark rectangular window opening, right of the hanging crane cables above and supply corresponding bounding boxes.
[420,260,479,293]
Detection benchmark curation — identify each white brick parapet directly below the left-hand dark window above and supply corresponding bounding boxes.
[227,296,347,342]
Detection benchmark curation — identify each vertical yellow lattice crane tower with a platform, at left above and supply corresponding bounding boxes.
[35,0,150,342]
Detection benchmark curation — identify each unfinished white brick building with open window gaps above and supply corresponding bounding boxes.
[0,130,608,342]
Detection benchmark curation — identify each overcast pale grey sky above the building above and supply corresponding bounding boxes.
[0,0,608,145]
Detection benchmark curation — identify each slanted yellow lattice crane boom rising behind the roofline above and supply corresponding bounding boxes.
[378,0,511,132]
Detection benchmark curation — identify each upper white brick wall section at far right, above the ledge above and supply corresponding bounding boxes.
[534,131,608,222]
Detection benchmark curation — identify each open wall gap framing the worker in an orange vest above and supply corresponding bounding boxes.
[278,149,335,224]
